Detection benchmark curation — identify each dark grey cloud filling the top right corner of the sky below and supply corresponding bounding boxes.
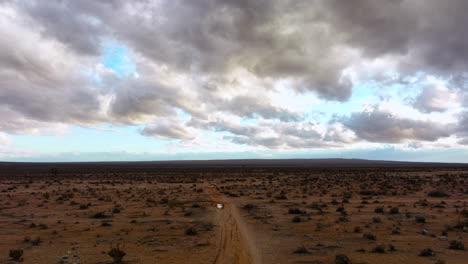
[323,0,468,83]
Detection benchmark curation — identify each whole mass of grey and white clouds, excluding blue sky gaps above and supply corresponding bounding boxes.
[0,0,468,148]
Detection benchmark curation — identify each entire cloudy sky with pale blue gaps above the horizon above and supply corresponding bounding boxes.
[0,0,468,162]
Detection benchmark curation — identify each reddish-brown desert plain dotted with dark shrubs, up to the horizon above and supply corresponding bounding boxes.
[0,160,468,264]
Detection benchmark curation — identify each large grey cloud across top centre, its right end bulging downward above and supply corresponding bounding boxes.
[6,0,358,100]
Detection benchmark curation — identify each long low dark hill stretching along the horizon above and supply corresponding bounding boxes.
[0,159,468,173]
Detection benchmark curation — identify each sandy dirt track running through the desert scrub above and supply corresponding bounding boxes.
[207,188,260,264]
